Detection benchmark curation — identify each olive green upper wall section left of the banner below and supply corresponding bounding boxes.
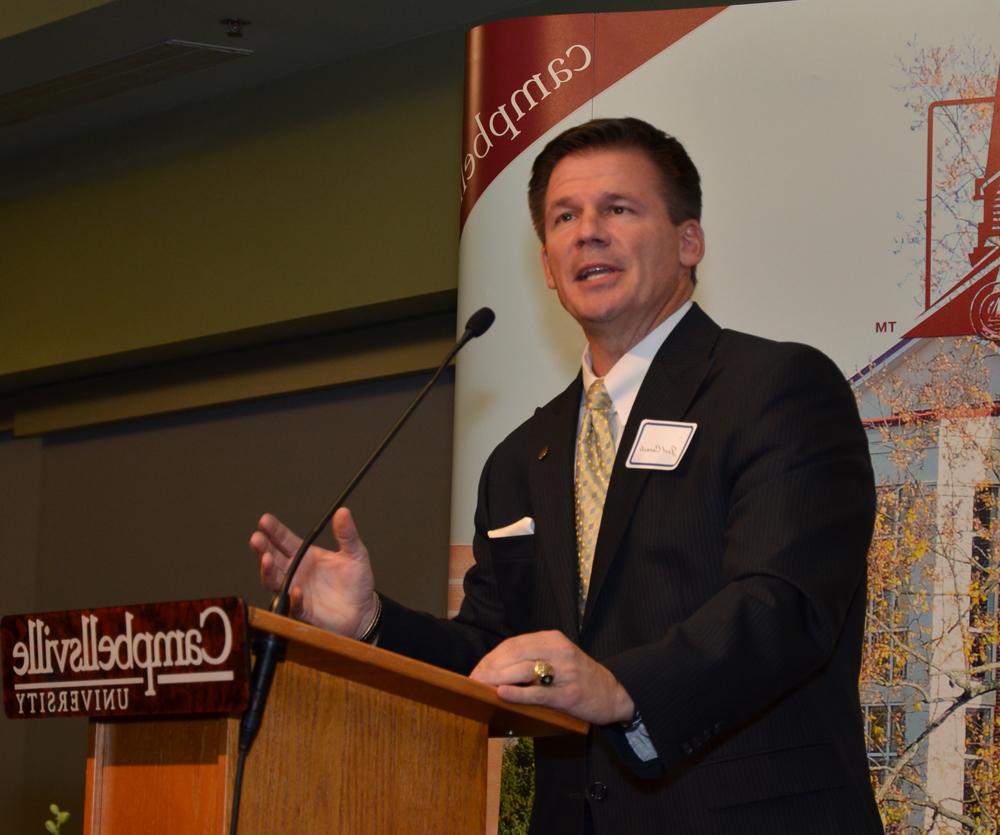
[0,27,464,390]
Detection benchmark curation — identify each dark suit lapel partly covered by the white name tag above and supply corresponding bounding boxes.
[584,305,720,623]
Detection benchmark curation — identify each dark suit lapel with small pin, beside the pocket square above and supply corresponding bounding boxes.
[529,375,583,640]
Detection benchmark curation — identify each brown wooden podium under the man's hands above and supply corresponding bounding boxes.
[84,609,587,835]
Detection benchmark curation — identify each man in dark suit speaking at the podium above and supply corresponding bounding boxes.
[251,119,882,835]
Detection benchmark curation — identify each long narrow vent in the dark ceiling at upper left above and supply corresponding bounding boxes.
[0,40,253,127]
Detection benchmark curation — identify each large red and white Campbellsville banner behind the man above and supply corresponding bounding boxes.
[452,0,1000,832]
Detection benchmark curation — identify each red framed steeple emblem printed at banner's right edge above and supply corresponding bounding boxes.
[904,65,1000,342]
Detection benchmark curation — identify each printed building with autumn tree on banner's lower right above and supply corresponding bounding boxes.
[859,337,1000,835]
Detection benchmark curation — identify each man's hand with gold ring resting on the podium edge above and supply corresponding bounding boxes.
[470,631,635,725]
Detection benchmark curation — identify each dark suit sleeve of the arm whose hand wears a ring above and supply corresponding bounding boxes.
[602,346,875,777]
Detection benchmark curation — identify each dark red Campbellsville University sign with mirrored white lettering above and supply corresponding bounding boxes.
[0,597,250,719]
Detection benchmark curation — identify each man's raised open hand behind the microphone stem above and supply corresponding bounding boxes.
[250,507,375,637]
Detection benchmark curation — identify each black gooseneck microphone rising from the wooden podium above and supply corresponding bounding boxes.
[230,307,496,835]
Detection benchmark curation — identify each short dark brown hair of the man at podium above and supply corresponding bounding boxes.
[528,116,701,242]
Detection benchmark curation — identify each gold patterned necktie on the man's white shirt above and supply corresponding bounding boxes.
[575,378,615,618]
